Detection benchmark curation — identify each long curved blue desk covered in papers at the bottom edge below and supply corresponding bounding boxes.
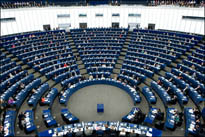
[38,121,162,137]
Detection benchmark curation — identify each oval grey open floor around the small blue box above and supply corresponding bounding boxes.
[68,85,134,122]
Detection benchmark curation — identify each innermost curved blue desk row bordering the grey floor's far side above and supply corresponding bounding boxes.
[60,78,141,104]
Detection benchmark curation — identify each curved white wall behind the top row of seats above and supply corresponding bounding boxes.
[1,5,204,35]
